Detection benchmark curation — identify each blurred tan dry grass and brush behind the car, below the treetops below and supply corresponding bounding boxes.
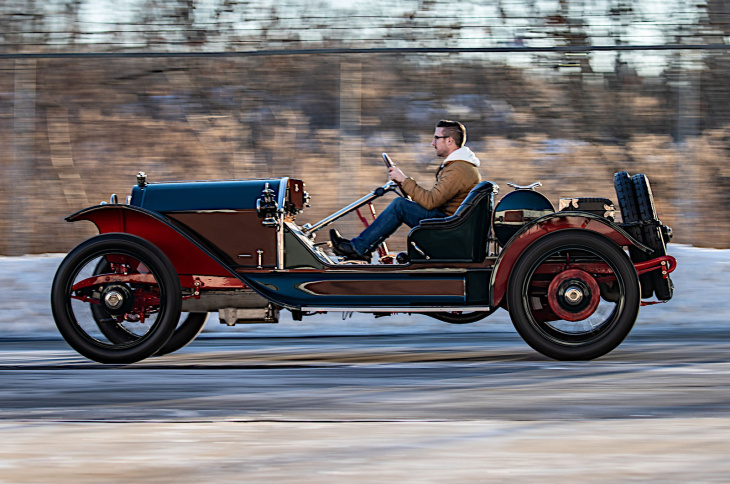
[0,57,730,254]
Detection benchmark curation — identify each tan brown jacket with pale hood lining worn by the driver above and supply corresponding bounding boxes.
[402,160,482,215]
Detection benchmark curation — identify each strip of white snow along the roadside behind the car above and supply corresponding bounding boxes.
[0,244,730,338]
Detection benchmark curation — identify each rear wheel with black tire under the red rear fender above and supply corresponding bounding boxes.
[507,230,641,360]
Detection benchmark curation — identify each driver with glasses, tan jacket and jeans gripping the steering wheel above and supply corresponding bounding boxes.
[330,119,481,261]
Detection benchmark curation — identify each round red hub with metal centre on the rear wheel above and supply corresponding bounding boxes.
[548,269,601,321]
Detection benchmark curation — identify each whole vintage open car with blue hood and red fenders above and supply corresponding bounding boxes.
[51,154,676,363]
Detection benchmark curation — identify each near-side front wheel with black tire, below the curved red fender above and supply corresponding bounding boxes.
[51,234,182,364]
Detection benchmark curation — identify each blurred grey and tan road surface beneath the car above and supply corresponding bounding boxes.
[0,329,730,483]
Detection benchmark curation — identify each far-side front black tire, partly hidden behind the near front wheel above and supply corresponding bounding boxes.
[89,258,208,356]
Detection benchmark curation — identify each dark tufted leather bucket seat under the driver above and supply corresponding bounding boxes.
[408,181,499,262]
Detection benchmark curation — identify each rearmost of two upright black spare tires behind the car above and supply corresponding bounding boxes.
[632,173,674,301]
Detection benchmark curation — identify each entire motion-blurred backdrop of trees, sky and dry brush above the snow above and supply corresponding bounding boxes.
[0,0,730,255]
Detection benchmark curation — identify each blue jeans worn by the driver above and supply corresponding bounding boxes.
[350,197,446,255]
